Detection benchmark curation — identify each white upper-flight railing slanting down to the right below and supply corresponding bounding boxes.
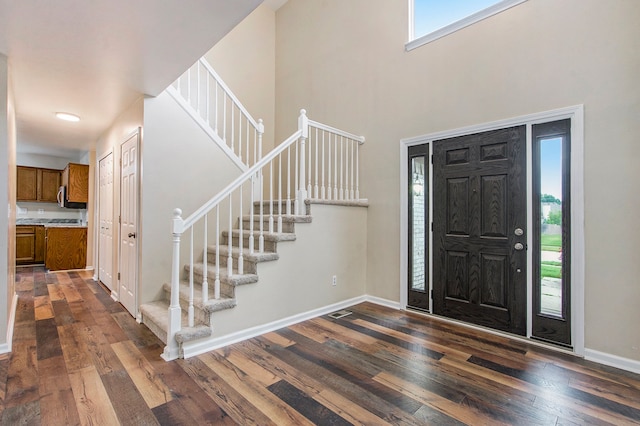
[167,58,264,170]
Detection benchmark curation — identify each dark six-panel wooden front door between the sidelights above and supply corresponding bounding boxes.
[433,126,527,335]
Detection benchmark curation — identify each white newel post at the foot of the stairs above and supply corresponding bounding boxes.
[162,209,184,361]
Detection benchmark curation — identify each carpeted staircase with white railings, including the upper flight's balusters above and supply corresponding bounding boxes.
[140,60,366,360]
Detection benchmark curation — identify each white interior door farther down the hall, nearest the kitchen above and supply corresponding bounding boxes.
[98,153,113,291]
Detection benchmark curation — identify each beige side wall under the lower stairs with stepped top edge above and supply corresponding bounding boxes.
[181,200,367,358]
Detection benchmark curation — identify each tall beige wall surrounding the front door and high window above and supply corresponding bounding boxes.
[276,0,640,360]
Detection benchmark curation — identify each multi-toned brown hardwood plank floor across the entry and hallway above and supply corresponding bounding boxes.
[0,268,640,425]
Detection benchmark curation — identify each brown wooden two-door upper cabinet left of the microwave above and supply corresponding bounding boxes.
[16,166,61,203]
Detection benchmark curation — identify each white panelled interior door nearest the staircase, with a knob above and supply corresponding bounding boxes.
[118,132,139,317]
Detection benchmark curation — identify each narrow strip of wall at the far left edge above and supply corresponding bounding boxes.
[0,54,16,352]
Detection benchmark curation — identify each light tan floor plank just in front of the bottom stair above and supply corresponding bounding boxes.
[111,341,173,408]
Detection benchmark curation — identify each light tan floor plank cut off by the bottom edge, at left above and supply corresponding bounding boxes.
[69,366,119,425]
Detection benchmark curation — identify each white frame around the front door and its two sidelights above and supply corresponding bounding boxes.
[400,105,585,356]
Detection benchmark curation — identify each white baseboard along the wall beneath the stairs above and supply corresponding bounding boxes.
[182,296,368,358]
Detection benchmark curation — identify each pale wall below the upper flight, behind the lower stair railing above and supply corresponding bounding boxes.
[139,92,240,303]
